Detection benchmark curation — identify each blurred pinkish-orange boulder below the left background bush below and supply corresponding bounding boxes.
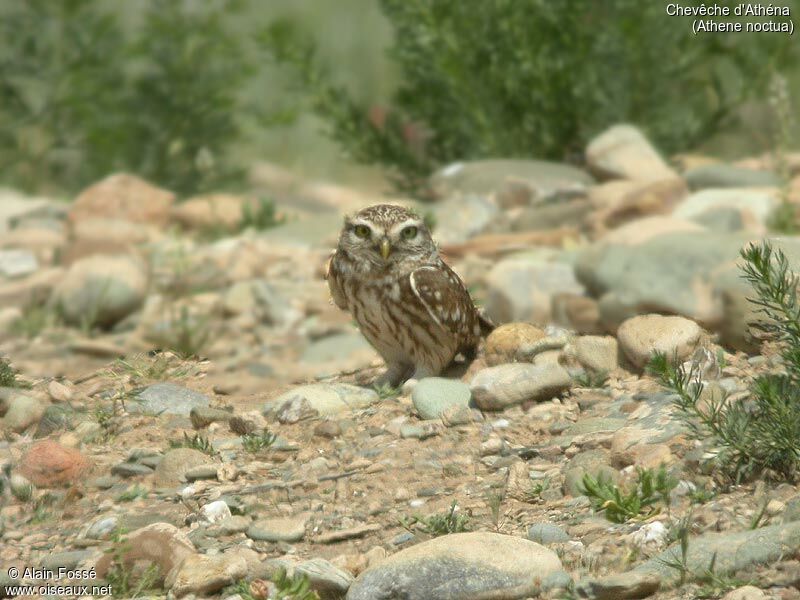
[68,173,175,227]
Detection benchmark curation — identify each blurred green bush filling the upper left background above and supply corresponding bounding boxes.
[0,0,266,193]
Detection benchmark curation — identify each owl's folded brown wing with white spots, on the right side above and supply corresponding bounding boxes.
[409,263,480,341]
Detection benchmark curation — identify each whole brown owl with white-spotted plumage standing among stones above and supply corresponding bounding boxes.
[327,204,491,385]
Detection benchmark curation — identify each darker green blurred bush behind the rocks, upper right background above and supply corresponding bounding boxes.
[265,0,791,195]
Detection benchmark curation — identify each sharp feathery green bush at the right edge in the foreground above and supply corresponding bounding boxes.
[650,242,800,481]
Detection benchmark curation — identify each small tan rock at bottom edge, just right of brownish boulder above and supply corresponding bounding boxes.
[165,554,247,598]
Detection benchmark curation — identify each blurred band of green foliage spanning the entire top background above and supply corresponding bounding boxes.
[0,0,800,194]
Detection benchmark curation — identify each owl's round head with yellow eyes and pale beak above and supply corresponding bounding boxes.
[339,204,437,265]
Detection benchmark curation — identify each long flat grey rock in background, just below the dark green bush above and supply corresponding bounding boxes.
[431,159,593,202]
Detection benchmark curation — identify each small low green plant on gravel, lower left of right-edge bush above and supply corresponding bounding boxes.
[582,466,678,523]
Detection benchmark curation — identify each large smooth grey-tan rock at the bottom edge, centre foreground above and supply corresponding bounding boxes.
[347,532,561,600]
